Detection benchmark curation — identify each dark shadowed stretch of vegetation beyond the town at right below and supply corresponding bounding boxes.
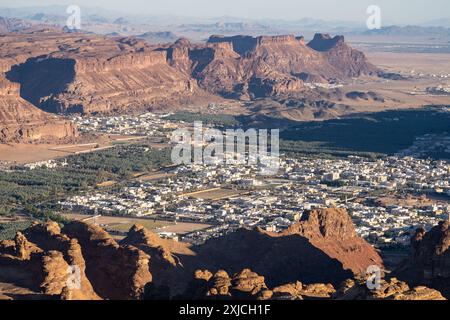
[280,107,450,157]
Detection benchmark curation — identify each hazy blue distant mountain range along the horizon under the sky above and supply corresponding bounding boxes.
[0,5,450,36]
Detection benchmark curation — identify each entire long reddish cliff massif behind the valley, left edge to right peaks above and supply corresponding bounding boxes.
[0,30,380,123]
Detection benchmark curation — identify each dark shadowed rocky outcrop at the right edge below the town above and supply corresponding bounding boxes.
[394,221,450,298]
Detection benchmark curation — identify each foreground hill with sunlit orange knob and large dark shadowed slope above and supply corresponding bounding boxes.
[181,209,382,287]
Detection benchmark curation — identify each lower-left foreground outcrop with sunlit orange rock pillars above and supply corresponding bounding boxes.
[0,222,152,300]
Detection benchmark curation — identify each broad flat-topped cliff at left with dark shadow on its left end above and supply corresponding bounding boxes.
[1,34,197,113]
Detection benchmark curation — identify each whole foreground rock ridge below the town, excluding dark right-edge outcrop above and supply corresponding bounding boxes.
[0,218,444,300]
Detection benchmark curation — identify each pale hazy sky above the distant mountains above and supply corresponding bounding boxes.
[0,0,450,24]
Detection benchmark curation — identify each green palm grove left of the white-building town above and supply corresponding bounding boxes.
[0,144,170,222]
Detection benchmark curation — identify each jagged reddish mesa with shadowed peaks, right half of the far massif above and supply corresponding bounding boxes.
[201,35,376,98]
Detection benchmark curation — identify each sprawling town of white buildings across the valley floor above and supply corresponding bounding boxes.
[59,147,450,247]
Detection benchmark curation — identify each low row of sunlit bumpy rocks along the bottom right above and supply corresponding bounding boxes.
[186,269,445,300]
